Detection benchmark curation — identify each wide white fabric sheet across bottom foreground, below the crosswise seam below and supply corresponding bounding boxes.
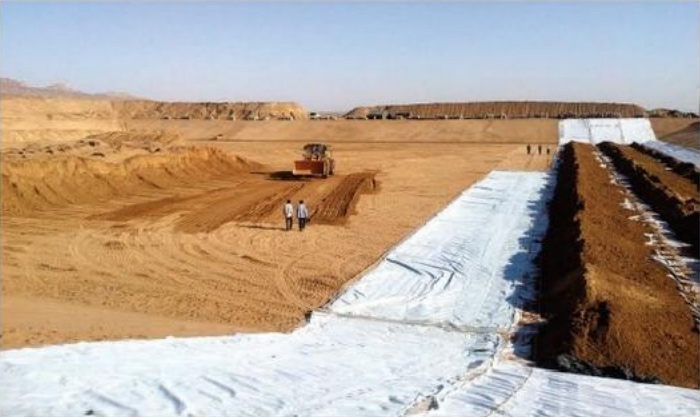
[0,315,498,417]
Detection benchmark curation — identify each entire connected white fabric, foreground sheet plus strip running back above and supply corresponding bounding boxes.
[0,172,700,417]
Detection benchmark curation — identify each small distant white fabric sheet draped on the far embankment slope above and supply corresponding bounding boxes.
[559,119,656,145]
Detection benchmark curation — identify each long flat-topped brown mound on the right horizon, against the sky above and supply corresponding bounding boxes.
[345,101,646,119]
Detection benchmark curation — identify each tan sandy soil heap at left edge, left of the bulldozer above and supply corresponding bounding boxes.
[2,148,254,217]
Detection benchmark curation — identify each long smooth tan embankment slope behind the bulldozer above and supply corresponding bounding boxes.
[127,119,558,144]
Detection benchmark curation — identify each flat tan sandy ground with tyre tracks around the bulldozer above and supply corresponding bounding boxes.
[2,135,549,348]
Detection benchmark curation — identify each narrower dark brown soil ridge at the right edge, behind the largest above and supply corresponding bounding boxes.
[598,143,700,257]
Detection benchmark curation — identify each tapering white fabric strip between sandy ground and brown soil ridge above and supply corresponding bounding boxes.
[330,172,551,328]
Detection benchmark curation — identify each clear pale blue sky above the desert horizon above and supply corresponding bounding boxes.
[0,1,700,111]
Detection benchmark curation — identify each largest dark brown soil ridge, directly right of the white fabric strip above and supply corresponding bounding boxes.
[535,144,700,387]
